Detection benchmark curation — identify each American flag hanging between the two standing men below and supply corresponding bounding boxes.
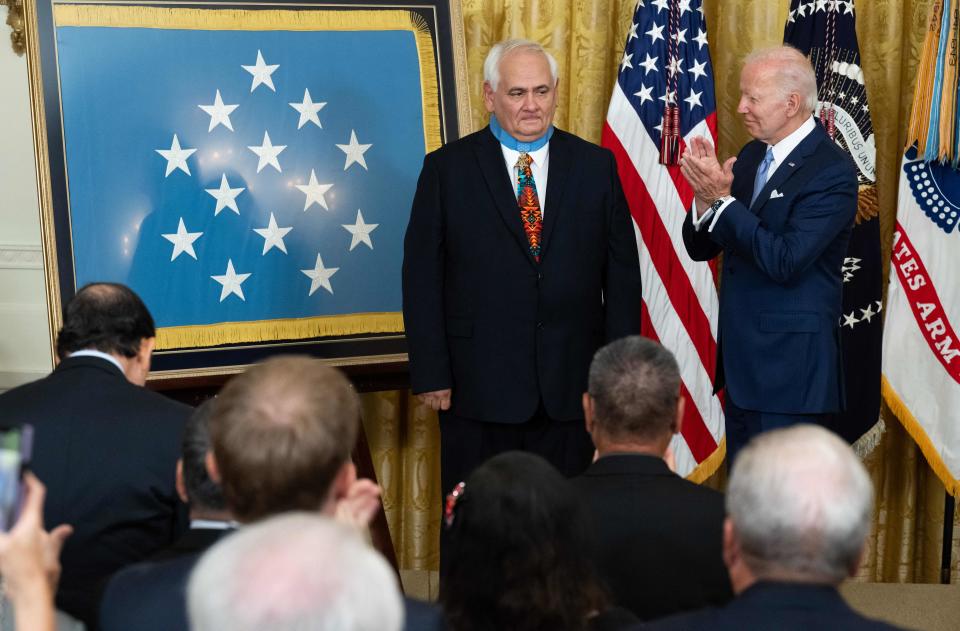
[601,0,724,481]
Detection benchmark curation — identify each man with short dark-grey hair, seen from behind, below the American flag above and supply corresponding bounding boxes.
[572,336,733,620]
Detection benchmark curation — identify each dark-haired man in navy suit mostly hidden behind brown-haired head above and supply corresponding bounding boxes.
[100,400,234,631]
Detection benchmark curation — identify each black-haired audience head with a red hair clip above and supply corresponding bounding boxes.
[440,452,605,631]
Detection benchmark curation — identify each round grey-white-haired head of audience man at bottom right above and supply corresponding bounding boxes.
[724,425,873,593]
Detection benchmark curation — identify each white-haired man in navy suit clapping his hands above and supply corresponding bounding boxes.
[681,46,857,460]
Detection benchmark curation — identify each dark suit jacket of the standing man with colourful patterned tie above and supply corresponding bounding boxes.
[403,128,640,422]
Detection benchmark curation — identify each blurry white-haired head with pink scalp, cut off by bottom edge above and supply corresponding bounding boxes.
[187,513,403,631]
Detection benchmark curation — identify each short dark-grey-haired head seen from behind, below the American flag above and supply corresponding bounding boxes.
[583,335,683,456]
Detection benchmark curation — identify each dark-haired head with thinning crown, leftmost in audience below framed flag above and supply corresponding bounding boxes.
[57,283,157,359]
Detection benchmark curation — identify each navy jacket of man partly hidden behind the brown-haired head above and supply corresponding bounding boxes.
[100,528,232,631]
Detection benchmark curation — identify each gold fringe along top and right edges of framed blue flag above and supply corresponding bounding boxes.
[53,4,442,153]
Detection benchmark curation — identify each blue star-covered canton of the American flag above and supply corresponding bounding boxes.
[618,0,717,145]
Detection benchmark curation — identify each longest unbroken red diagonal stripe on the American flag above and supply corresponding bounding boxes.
[602,124,717,378]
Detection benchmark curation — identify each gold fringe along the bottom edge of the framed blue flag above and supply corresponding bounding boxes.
[157,313,404,350]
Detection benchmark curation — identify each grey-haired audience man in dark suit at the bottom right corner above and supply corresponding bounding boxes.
[643,425,895,631]
